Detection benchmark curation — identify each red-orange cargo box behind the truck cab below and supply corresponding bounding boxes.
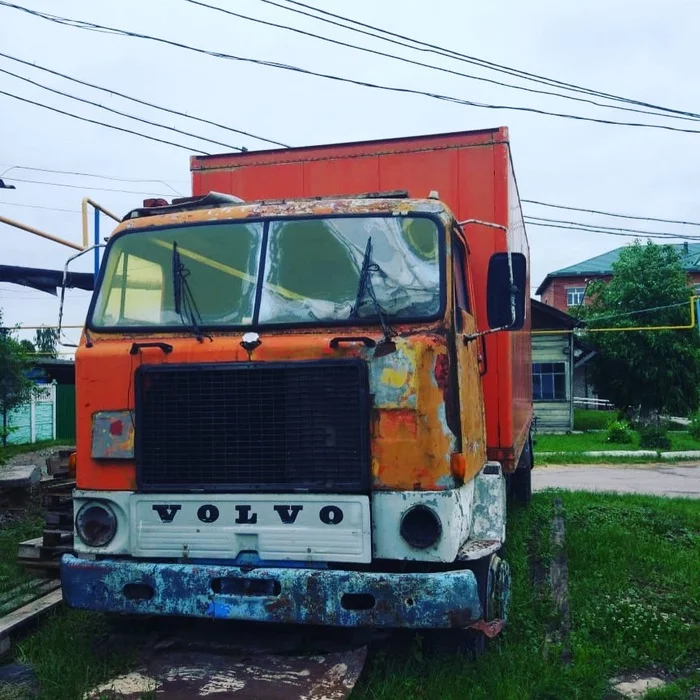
[190,128,533,472]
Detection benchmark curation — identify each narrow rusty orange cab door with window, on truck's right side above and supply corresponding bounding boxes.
[451,229,486,482]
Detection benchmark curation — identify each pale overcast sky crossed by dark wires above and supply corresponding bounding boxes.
[0,0,700,352]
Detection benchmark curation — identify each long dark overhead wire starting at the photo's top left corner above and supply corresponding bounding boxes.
[0,0,700,134]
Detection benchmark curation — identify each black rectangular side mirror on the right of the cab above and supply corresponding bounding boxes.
[486,253,527,331]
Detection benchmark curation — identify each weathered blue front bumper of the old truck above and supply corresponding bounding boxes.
[61,554,481,628]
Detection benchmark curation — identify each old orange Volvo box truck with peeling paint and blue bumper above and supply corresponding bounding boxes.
[61,128,533,638]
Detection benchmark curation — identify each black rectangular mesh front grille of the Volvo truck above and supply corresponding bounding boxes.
[136,360,369,493]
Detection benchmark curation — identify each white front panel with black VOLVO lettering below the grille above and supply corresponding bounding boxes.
[130,494,372,563]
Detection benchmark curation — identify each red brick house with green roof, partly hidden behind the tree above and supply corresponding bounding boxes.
[536,243,700,312]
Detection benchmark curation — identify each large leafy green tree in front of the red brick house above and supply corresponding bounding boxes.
[585,241,700,423]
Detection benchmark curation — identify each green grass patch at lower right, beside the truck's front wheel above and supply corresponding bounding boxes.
[352,492,700,700]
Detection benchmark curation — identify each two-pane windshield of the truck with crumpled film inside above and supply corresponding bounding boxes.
[91,216,440,328]
